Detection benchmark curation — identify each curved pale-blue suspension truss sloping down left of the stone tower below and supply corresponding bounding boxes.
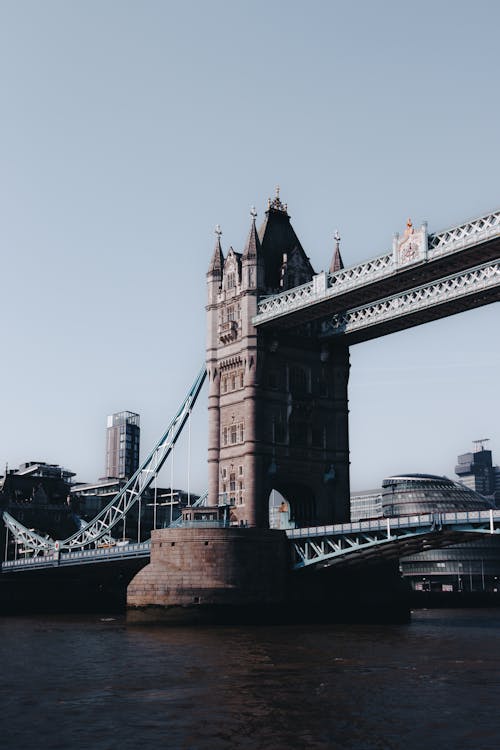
[3,366,206,556]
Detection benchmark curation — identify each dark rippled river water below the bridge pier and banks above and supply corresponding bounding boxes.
[0,609,500,750]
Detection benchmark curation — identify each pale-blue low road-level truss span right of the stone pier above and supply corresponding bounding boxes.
[287,510,500,570]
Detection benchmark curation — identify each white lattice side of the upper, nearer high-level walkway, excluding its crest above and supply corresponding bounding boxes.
[254,211,500,325]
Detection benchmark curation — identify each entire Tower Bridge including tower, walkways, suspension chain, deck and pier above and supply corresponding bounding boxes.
[2,194,500,624]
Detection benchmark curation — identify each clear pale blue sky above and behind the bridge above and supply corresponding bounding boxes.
[0,0,500,500]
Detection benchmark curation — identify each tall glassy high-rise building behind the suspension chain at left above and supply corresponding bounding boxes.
[106,411,141,479]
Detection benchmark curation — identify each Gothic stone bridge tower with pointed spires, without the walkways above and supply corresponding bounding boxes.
[207,191,349,528]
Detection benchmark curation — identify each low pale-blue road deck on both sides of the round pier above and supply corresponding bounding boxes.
[2,510,500,573]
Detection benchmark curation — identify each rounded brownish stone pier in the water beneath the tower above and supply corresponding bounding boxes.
[127,528,289,625]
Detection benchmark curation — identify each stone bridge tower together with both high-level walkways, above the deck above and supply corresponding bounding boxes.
[207,194,500,526]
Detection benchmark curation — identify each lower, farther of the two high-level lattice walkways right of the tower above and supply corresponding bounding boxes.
[322,261,500,336]
